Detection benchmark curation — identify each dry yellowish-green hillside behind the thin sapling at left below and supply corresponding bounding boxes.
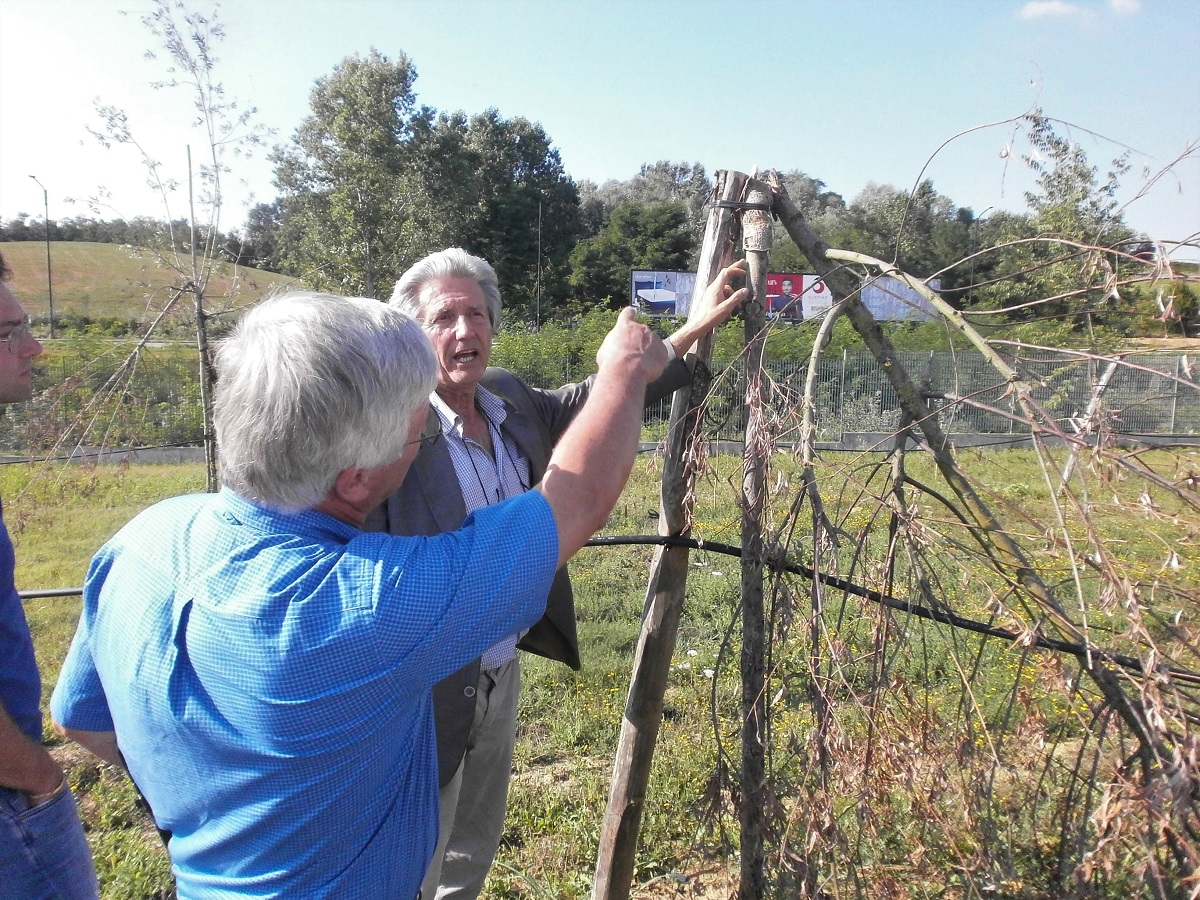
[0,241,302,322]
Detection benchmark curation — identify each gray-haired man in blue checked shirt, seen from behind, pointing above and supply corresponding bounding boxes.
[52,293,666,900]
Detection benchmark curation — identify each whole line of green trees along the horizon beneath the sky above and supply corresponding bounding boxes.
[0,49,1196,338]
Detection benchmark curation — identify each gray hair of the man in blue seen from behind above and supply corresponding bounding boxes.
[214,292,437,511]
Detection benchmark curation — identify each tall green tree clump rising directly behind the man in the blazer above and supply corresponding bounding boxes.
[279,56,578,319]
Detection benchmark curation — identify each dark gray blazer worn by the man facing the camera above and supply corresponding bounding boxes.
[365,360,691,786]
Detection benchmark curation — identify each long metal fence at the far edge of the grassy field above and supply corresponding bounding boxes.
[0,352,1200,454]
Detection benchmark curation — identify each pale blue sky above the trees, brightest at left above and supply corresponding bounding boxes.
[0,0,1200,258]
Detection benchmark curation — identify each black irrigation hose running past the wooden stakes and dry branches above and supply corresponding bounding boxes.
[587,534,1200,684]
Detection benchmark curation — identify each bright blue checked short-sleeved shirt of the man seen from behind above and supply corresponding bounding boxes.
[52,491,558,899]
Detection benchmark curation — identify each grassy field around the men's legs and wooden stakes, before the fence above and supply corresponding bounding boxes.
[9,451,1195,900]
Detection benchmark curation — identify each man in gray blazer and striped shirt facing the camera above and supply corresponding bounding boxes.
[366,247,748,900]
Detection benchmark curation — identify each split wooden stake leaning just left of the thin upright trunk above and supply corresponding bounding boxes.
[592,172,748,900]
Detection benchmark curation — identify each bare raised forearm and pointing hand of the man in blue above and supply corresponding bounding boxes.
[538,307,667,565]
